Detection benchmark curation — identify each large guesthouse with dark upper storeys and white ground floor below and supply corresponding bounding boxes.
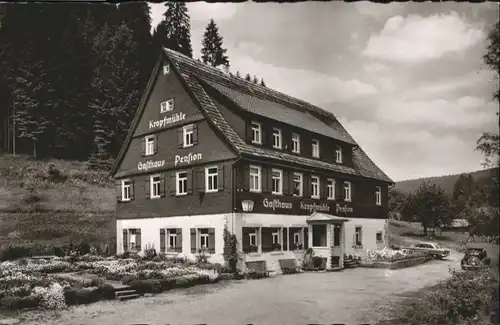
[112,50,393,270]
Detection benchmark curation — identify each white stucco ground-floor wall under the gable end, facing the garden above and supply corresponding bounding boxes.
[116,214,231,264]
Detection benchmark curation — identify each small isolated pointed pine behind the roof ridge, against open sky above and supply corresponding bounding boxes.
[201,19,229,67]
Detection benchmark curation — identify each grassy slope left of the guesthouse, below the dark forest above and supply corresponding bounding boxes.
[0,155,116,246]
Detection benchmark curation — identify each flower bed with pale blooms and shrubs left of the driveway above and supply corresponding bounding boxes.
[0,255,222,309]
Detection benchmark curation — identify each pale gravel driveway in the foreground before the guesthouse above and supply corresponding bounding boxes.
[14,252,461,325]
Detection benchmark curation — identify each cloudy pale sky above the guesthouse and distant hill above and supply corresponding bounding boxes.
[150,2,499,181]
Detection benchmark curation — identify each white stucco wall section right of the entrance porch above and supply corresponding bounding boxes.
[344,218,387,256]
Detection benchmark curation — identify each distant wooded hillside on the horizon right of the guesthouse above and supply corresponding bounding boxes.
[394,168,498,196]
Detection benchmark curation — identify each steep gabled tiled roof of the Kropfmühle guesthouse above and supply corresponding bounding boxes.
[112,49,393,183]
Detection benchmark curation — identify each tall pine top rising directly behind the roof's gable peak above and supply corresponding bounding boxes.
[153,2,193,57]
